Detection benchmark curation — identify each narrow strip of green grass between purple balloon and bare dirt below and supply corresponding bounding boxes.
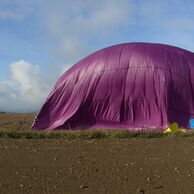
[0,130,194,140]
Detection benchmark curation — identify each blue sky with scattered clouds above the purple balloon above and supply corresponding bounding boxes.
[0,0,194,112]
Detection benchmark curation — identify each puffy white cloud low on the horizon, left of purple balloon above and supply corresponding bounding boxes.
[0,60,64,112]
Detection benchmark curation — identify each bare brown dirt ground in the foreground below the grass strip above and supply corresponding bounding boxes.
[0,137,194,194]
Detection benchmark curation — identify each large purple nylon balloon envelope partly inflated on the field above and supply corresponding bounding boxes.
[32,43,194,130]
